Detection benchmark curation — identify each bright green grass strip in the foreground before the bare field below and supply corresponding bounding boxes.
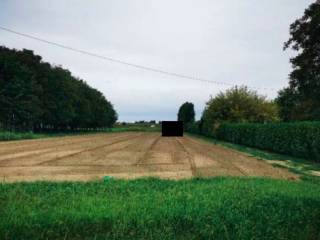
[0,178,320,240]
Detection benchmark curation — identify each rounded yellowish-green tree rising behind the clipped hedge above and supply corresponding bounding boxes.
[203,87,278,134]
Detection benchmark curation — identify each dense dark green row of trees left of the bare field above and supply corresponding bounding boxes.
[0,46,117,131]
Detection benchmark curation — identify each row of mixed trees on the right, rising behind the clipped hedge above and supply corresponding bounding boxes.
[178,0,320,135]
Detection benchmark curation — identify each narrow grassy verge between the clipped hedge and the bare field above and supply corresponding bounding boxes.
[188,133,320,183]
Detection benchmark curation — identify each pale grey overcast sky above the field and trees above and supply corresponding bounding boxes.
[0,0,314,122]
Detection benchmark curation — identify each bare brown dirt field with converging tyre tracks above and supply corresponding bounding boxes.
[0,132,297,182]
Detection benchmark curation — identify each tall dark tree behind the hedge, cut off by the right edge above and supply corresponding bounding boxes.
[277,0,320,121]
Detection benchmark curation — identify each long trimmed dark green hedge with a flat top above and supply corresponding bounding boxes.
[216,122,320,162]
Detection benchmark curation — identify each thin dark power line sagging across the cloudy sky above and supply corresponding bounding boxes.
[0,26,275,91]
